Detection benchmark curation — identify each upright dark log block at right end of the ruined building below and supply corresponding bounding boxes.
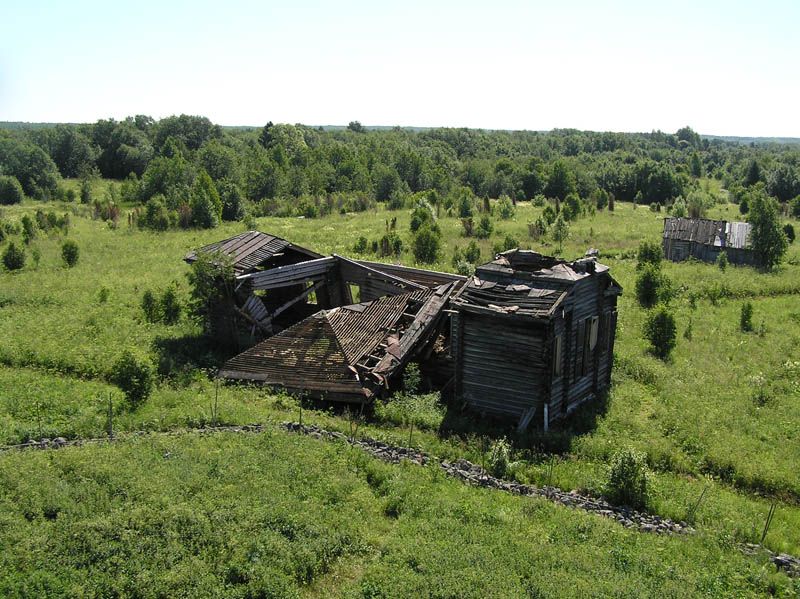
[451,250,622,430]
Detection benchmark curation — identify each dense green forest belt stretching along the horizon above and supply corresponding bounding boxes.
[0,115,800,228]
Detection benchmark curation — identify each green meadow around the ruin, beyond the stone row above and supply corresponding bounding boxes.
[0,193,800,592]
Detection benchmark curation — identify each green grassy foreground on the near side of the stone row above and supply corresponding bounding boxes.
[0,432,791,597]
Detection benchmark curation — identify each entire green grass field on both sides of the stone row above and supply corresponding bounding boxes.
[0,189,800,596]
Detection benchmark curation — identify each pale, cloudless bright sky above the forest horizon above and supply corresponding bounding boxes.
[0,0,800,137]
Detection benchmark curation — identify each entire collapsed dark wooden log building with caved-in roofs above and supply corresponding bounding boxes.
[185,231,621,428]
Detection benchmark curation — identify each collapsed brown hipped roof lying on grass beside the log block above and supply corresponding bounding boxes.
[219,283,455,402]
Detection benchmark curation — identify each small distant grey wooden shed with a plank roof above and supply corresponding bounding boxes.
[662,216,756,264]
